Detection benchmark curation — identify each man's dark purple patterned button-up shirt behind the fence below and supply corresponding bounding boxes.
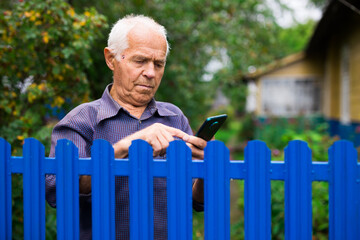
[46,84,197,239]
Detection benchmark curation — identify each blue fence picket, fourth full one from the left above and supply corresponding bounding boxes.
[129,140,154,239]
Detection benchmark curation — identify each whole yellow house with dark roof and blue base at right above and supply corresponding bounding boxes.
[245,0,360,146]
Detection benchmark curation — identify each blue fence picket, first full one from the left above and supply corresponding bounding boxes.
[23,138,45,240]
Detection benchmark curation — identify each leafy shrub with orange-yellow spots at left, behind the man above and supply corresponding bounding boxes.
[0,0,106,154]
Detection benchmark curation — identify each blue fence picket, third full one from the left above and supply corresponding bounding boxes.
[91,140,115,239]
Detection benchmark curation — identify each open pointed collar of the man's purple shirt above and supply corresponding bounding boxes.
[96,83,178,123]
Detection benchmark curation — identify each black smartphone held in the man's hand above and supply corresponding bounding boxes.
[195,114,227,141]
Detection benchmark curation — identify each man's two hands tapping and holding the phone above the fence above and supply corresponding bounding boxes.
[113,123,206,159]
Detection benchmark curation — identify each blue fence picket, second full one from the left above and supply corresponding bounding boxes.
[55,139,79,240]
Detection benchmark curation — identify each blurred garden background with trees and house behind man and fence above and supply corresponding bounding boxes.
[0,0,360,239]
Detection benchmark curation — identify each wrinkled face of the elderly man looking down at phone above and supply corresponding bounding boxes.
[111,26,167,107]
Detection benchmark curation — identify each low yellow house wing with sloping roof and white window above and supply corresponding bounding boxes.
[247,53,323,117]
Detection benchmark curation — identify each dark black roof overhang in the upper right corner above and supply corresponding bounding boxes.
[305,0,360,54]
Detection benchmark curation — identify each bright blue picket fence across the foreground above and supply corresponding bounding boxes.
[0,138,360,240]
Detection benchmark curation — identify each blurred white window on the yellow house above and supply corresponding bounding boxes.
[261,77,320,117]
